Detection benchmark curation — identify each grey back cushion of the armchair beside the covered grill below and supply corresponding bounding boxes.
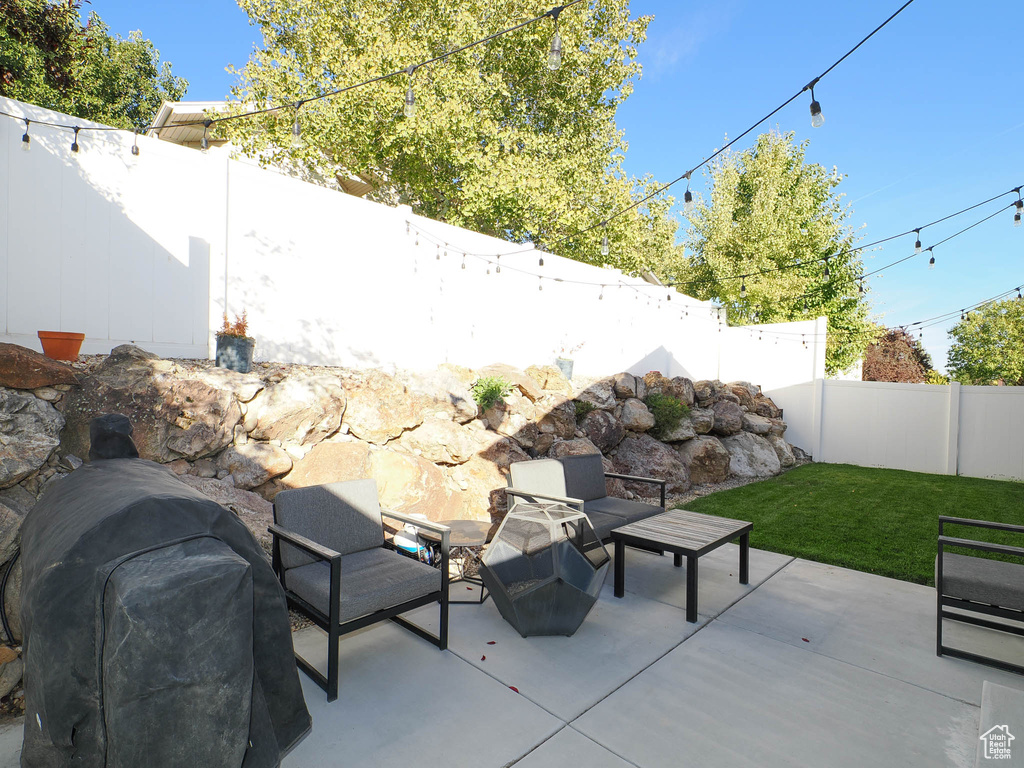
[273,479,384,568]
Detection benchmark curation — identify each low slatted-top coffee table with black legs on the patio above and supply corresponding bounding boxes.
[611,509,754,623]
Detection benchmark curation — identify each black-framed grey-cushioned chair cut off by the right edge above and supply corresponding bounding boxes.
[935,516,1024,675]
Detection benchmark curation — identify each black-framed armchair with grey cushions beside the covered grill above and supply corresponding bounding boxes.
[269,479,450,701]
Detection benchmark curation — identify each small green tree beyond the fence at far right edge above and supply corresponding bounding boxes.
[946,299,1024,386]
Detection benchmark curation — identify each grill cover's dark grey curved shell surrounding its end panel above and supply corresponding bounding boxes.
[22,459,311,768]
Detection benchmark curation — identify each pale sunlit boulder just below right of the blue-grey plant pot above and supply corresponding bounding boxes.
[246,375,346,445]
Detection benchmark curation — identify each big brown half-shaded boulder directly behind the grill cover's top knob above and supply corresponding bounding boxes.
[60,352,242,464]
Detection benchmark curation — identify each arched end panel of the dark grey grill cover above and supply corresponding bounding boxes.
[102,538,253,768]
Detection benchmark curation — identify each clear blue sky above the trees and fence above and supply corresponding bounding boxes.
[86,0,1024,367]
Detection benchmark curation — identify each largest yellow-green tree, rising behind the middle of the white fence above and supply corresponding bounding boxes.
[224,0,677,274]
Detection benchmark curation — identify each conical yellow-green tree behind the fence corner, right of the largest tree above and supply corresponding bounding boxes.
[678,131,877,374]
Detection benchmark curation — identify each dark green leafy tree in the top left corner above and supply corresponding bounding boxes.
[0,0,188,130]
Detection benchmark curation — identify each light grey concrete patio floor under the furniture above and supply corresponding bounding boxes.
[0,545,1024,768]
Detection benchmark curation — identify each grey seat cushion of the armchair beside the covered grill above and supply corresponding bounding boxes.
[285,548,441,623]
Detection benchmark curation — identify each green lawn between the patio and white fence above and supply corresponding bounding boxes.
[683,464,1024,585]
